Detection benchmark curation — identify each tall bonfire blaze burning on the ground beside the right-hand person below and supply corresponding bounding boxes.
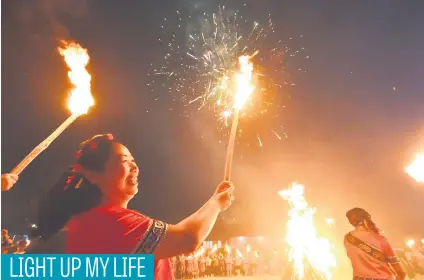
[278,183,336,279]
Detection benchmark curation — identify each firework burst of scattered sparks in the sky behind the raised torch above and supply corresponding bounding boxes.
[148,6,303,147]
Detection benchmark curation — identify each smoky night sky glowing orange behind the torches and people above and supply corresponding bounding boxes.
[1,0,424,242]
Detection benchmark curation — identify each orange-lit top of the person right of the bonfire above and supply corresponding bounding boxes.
[344,229,397,279]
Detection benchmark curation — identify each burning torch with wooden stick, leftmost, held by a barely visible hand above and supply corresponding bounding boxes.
[11,42,94,175]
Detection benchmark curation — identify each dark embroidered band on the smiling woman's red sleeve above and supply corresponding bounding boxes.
[134,219,168,254]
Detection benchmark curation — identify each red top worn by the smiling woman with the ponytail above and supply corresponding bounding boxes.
[66,203,173,280]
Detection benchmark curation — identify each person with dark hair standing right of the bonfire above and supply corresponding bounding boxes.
[344,208,406,280]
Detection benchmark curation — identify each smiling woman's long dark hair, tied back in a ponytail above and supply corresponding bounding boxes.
[31,134,114,241]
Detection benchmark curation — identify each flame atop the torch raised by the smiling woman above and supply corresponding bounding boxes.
[234,51,258,110]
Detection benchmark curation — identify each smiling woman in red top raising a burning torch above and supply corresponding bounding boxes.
[31,134,233,280]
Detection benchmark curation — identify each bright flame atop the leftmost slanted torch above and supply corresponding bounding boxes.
[58,42,94,115]
